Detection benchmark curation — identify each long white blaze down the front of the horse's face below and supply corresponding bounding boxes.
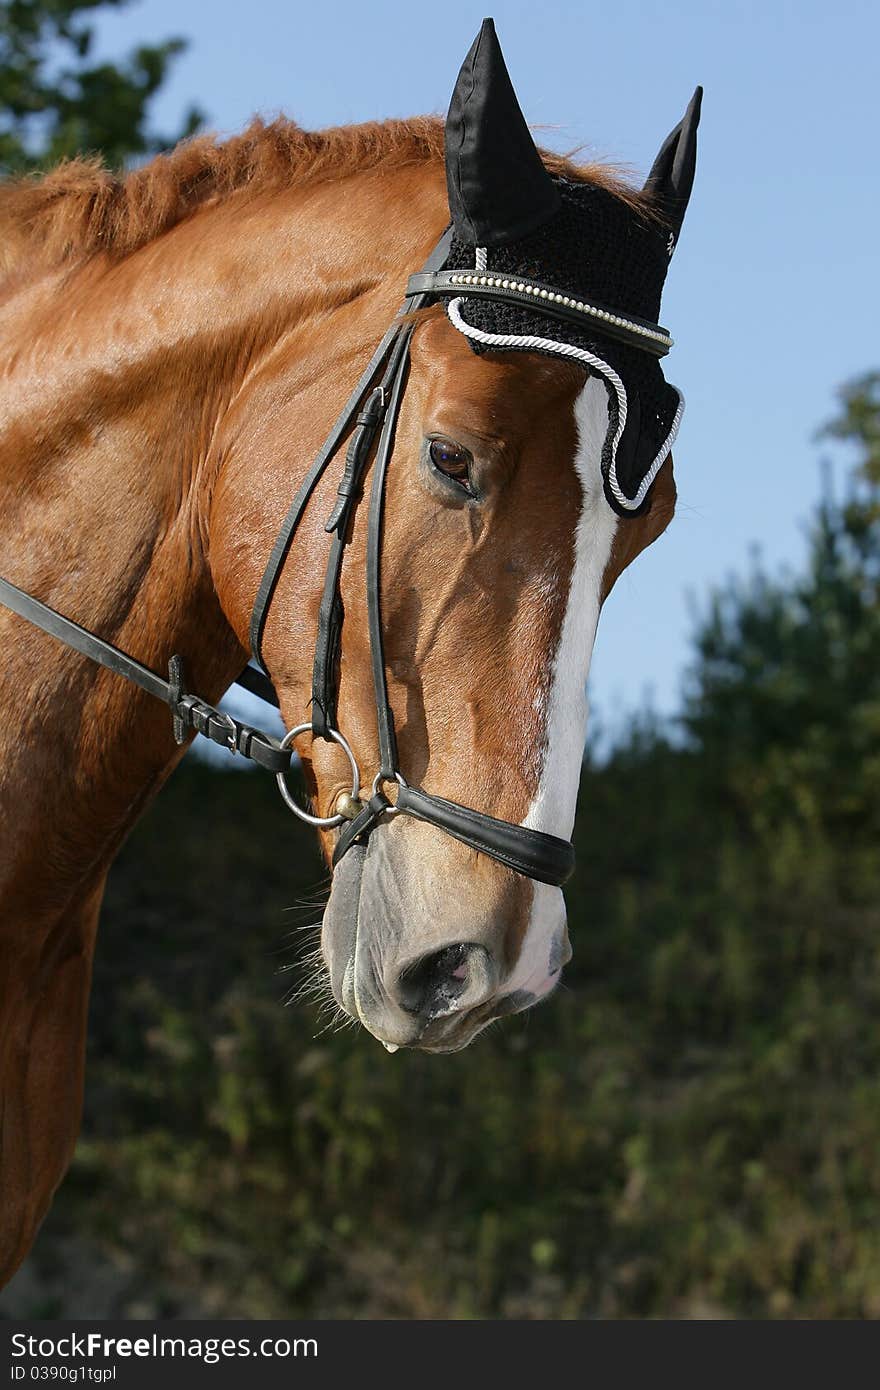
[507,377,617,995]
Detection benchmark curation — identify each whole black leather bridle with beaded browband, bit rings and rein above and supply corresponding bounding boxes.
[0,229,671,885]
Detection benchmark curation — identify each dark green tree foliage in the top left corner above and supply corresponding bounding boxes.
[0,0,203,175]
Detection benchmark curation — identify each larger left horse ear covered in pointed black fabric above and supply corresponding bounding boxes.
[446,19,559,246]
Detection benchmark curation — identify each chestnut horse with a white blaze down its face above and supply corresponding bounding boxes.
[0,25,695,1279]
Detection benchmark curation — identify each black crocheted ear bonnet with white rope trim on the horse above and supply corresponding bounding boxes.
[446,19,702,516]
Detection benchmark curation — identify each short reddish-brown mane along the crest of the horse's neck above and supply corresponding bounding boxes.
[0,117,649,275]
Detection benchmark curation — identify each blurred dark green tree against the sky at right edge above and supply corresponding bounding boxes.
[685,373,880,870]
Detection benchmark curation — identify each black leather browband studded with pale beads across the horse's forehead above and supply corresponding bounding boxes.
[406,270,671,357]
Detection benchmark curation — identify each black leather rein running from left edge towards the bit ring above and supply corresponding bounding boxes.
[0,578,291,773]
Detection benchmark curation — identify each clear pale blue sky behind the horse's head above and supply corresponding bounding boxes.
[91,0,880,726]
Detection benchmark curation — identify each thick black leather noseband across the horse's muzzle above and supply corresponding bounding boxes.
[396,787,574,887]
